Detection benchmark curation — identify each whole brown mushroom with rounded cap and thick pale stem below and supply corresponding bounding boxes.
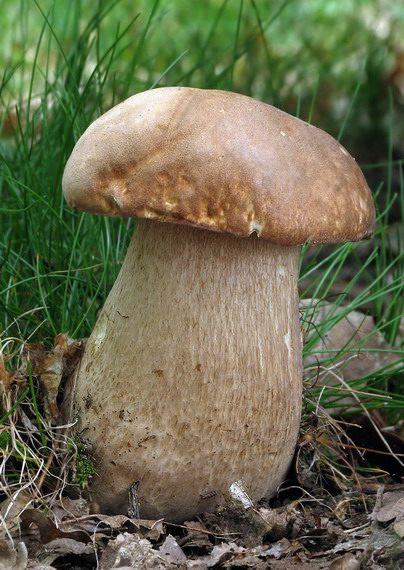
[63,87,374,521]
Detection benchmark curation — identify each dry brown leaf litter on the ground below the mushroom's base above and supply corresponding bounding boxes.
[0,482,404,570]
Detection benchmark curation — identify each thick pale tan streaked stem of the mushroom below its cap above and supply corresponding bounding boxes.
[73,220,302,521]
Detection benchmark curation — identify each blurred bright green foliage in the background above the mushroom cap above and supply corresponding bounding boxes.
[0,0,404,140]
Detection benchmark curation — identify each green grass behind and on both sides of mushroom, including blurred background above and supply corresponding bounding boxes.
[0,0,404,510]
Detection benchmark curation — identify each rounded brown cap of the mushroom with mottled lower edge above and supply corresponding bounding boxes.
[63,87,375,245]
